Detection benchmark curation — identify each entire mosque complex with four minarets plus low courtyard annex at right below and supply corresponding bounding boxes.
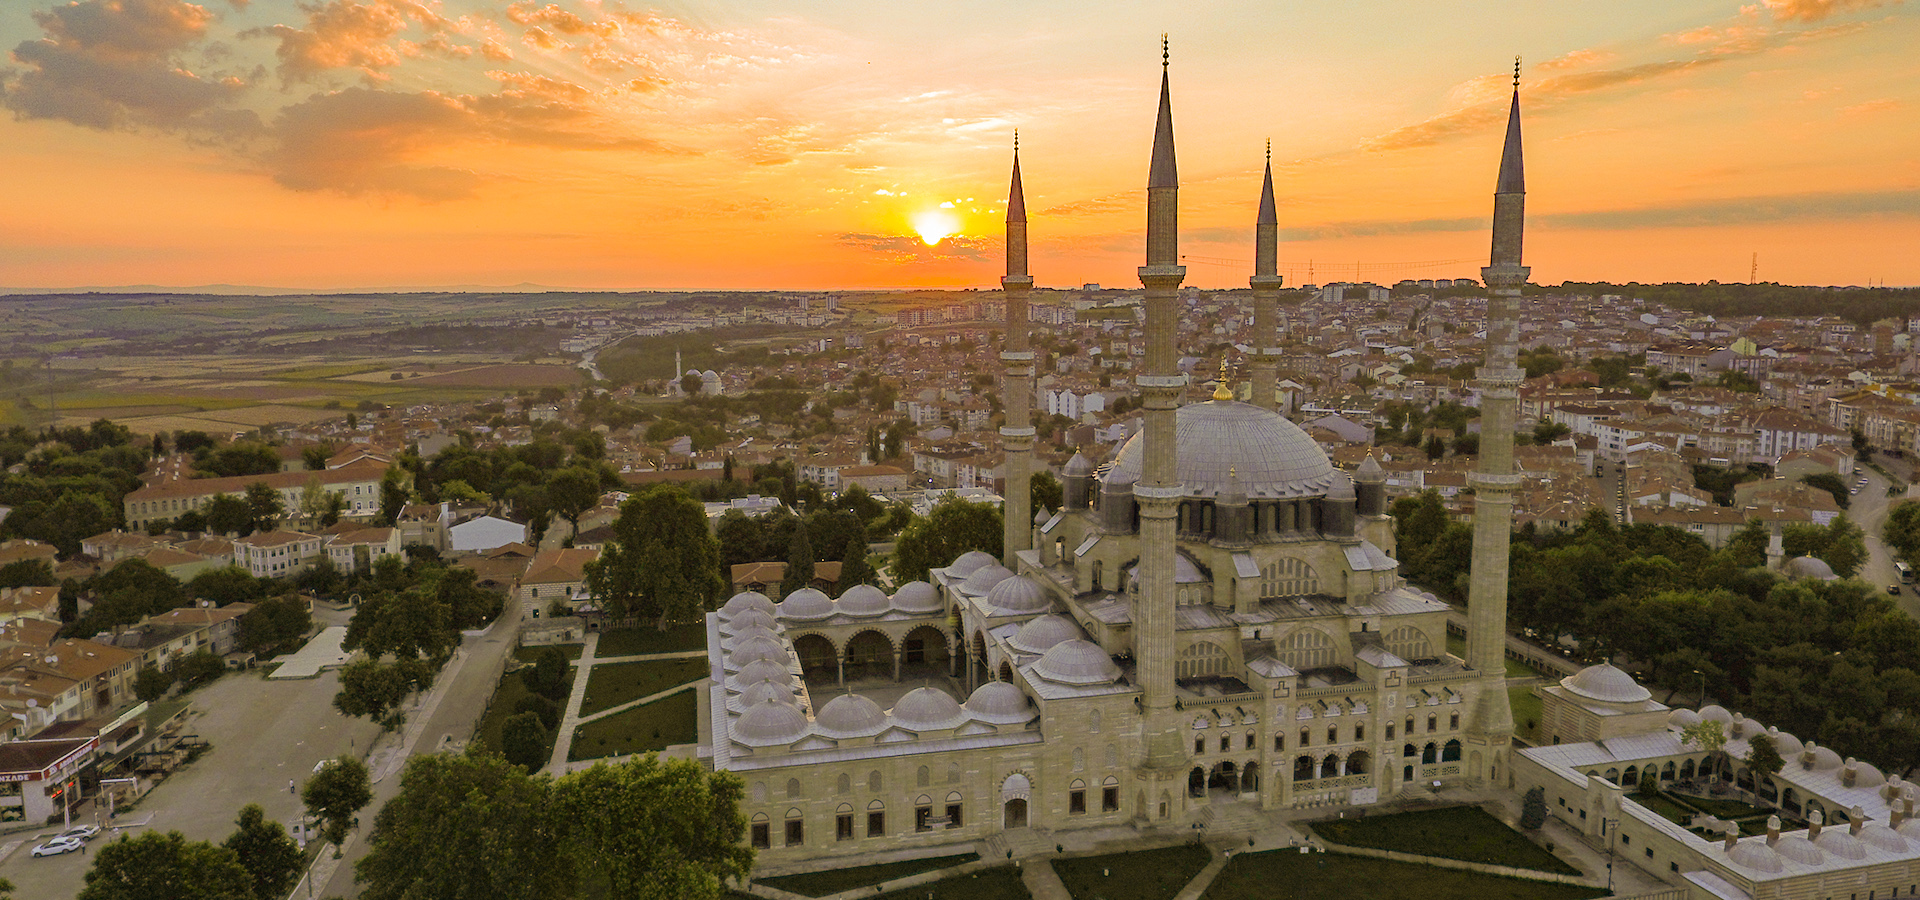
[699,50,1920,900]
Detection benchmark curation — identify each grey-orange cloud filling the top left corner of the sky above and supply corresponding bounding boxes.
[0,0,257,134]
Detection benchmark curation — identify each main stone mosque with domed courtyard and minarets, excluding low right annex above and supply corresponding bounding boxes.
[701,50,1524,865]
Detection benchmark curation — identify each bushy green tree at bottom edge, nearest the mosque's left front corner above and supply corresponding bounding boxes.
[553,752,753,900]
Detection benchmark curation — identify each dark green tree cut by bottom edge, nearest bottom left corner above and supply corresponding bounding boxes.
[79,831,253,900]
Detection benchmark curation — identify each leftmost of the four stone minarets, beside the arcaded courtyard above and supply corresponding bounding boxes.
[1000,130,1033,572]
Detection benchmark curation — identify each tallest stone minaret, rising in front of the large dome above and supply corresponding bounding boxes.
[1133,38,1187,771]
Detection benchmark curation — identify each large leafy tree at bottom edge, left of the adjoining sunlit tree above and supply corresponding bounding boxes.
[353,752,568,900]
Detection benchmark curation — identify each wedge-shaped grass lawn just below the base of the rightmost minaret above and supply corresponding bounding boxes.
[1311,806,1580,875]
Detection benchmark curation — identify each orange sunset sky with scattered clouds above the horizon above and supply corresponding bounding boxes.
[0,0,1920,290]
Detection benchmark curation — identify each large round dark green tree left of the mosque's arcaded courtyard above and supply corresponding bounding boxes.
[588,486,726,629]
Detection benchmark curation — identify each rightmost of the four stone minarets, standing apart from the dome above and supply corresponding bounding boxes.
[1467,59,1528,785]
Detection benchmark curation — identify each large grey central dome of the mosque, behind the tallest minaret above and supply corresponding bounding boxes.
[1104,399,1334,499]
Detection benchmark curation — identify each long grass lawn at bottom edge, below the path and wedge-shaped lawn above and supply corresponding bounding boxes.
[1202,850,1607,900]
